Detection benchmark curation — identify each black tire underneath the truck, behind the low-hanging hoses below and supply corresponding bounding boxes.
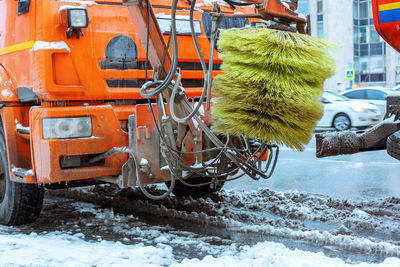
[165,177,225,198]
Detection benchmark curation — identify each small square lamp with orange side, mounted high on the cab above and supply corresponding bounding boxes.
[59,6,89,29]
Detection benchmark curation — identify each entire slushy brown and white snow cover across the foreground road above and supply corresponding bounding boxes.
[0,142,400,267]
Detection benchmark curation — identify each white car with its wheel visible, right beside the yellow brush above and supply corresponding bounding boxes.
[317,91,381,131]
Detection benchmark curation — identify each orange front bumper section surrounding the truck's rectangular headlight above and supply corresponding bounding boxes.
[29,105,130,184]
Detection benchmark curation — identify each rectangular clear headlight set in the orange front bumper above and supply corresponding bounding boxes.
[43,117,92,139]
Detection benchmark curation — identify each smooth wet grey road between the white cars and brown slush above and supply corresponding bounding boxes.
[224,140,400,199]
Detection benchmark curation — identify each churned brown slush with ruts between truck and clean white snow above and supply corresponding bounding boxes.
[37,186,400,265]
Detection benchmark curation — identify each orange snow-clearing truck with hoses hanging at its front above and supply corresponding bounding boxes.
[0,0,304,225]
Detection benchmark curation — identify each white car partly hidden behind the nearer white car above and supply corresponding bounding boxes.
[340,87,394,120]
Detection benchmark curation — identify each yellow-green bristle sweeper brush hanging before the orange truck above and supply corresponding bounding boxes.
[212,28,335,153]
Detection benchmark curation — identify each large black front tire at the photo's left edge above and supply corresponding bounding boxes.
[0,123,44,226]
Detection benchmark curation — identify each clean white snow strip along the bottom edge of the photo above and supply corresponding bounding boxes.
[0,227,400,267]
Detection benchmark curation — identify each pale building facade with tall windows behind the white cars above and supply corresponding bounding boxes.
[309,0,400,91]
